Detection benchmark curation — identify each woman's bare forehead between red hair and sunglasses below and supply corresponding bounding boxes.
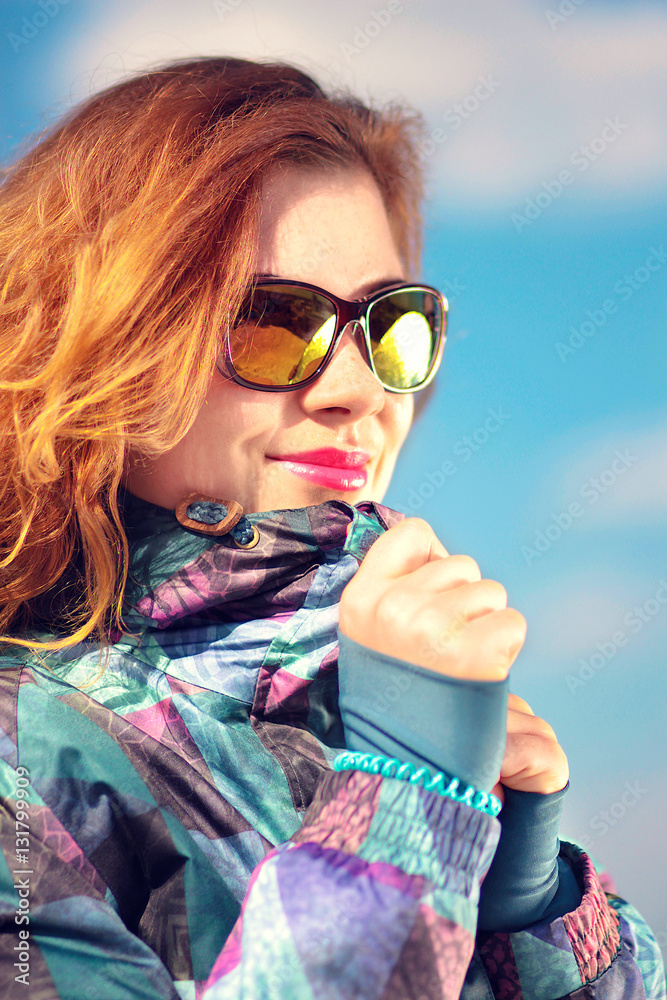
[255,168,404,298]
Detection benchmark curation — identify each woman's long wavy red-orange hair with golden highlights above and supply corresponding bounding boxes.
[0,58,422,650]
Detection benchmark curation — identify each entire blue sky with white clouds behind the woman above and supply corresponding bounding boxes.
[0,0,667,946]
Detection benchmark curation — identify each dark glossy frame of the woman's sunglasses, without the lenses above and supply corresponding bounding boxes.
[218,277,449,393]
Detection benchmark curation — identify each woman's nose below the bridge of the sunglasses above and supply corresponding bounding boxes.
[300,320,385,423]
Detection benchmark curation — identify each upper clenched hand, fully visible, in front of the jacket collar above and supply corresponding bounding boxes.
[339,517,526,681]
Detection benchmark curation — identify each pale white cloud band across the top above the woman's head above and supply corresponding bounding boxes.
[43,0,667,205]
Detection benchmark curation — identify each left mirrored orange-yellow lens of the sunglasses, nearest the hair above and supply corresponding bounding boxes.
[230,286,336,386]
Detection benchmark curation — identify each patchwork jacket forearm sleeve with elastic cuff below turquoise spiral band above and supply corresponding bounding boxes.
[203,771,499,1000]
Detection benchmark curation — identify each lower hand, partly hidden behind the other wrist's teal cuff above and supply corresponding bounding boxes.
[491,694,570,802]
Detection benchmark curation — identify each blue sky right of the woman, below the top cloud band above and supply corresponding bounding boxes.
[387,199,667,944]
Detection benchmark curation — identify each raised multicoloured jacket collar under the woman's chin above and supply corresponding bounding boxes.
[119,492,403,629]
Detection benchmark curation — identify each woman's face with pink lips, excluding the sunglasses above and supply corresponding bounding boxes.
[125,168,413,513]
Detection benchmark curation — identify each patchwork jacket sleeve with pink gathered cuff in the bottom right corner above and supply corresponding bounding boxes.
[472,842,667,1000]
